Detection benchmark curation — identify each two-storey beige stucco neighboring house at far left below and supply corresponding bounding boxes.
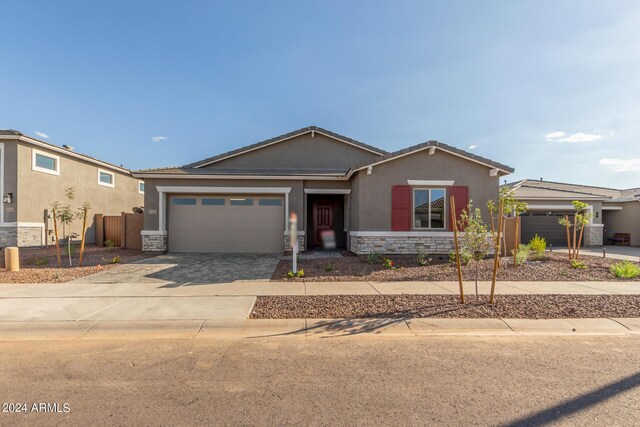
[0,130,144,247]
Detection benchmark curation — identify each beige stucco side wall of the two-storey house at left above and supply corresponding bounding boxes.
[14,142,144,243]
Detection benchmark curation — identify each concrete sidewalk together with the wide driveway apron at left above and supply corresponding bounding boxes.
[0,282,640,322]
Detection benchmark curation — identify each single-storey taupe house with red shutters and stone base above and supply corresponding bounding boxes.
[133,126,513,254]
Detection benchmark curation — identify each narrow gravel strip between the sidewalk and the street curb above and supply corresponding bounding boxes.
[251,295,640,319]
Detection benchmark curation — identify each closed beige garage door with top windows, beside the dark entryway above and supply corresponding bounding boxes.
[167,195,284,253]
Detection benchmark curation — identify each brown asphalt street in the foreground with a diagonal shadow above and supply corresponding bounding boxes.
[0,336,640,426]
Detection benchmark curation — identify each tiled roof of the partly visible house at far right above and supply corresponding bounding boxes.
[506,179,640,202]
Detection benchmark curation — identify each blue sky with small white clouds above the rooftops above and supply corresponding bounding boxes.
[0,0,640,187]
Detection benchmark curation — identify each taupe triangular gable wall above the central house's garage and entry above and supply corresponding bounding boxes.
[200,133,376,169]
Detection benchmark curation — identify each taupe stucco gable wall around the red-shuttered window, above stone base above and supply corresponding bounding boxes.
[351,150,499,231]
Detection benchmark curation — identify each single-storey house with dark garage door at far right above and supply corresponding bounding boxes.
[506,179,640,246]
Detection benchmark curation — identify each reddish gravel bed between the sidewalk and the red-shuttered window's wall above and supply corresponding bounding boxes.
[271,252,636,282]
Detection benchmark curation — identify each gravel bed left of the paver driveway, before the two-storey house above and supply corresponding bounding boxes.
[0,245,155,283]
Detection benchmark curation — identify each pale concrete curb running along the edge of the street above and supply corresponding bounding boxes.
[0,318,640,341]
